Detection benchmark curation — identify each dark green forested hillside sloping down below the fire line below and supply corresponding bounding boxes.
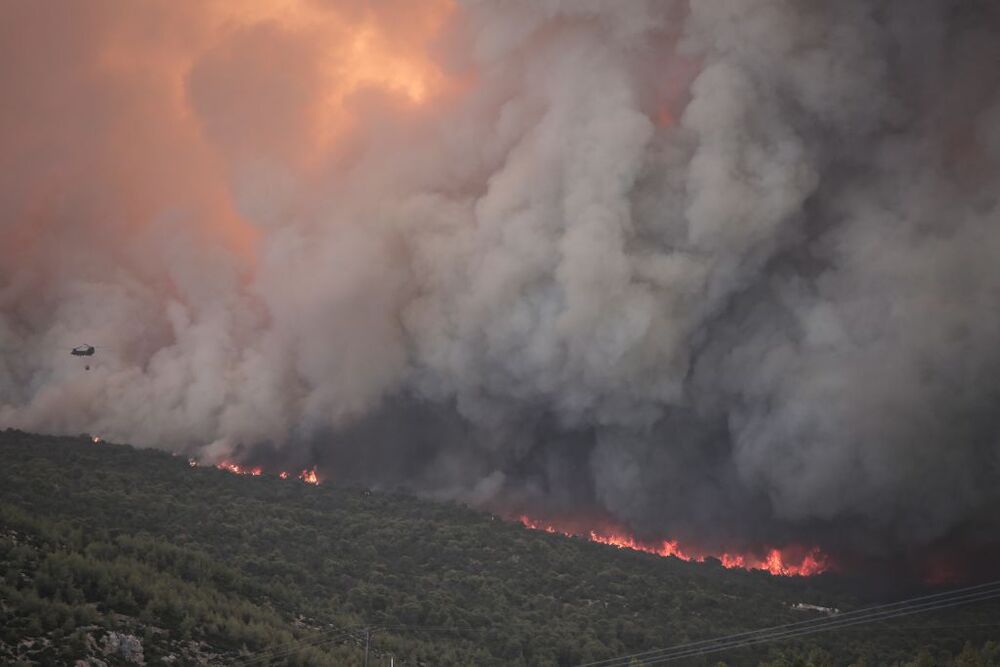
[0,430,1000,665]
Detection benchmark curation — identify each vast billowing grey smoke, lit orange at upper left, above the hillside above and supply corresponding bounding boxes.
[0,0,1000,576]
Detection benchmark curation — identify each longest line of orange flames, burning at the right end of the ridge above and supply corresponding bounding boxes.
[518,515,832,577]
